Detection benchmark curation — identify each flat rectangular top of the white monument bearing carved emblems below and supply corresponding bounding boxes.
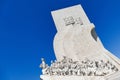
[51,5,90,31]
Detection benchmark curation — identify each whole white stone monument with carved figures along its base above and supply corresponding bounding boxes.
[40,5,120,80]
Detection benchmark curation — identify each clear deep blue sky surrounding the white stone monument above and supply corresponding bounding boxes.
[0,0,120,80]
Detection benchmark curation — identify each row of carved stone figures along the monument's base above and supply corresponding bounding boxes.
[40,57,118,76]
